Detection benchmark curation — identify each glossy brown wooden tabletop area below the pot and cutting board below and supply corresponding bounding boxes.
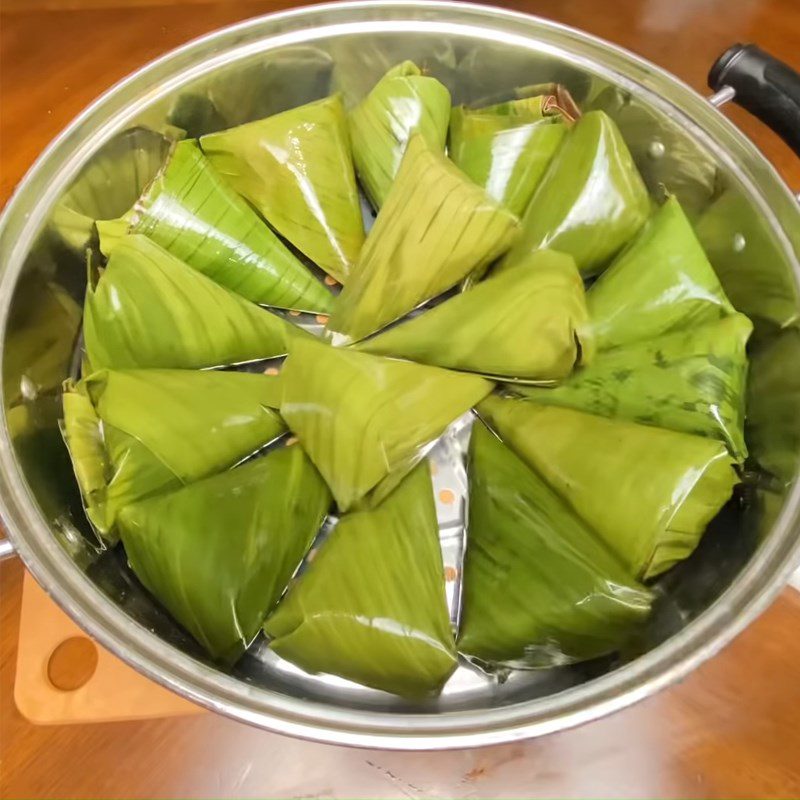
[0,563,800,800]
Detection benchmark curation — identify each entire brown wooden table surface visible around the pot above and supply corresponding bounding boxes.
[0,0,800,798]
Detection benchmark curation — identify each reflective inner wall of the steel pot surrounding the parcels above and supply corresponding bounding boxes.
[3,25,800,712]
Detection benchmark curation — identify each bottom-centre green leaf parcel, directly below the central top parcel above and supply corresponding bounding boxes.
[264,463,457,698]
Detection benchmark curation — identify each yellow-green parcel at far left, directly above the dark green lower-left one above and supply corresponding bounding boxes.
[64,370,285,539]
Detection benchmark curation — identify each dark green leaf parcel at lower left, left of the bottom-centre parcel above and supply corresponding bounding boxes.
[119,447,331,664]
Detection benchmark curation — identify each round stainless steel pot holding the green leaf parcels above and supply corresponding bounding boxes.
[0,2,800,749]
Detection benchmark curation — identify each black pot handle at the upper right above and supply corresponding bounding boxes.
[708,44,800,156]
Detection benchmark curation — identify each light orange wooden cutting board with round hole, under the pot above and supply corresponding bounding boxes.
[14,573,204,725]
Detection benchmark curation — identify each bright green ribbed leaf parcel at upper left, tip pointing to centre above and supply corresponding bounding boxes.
[97,140,333,312]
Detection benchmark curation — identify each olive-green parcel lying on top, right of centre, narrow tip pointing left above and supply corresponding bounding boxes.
[354,250,591,382]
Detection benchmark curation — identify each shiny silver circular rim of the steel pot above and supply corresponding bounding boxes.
[0,0,800,750]
